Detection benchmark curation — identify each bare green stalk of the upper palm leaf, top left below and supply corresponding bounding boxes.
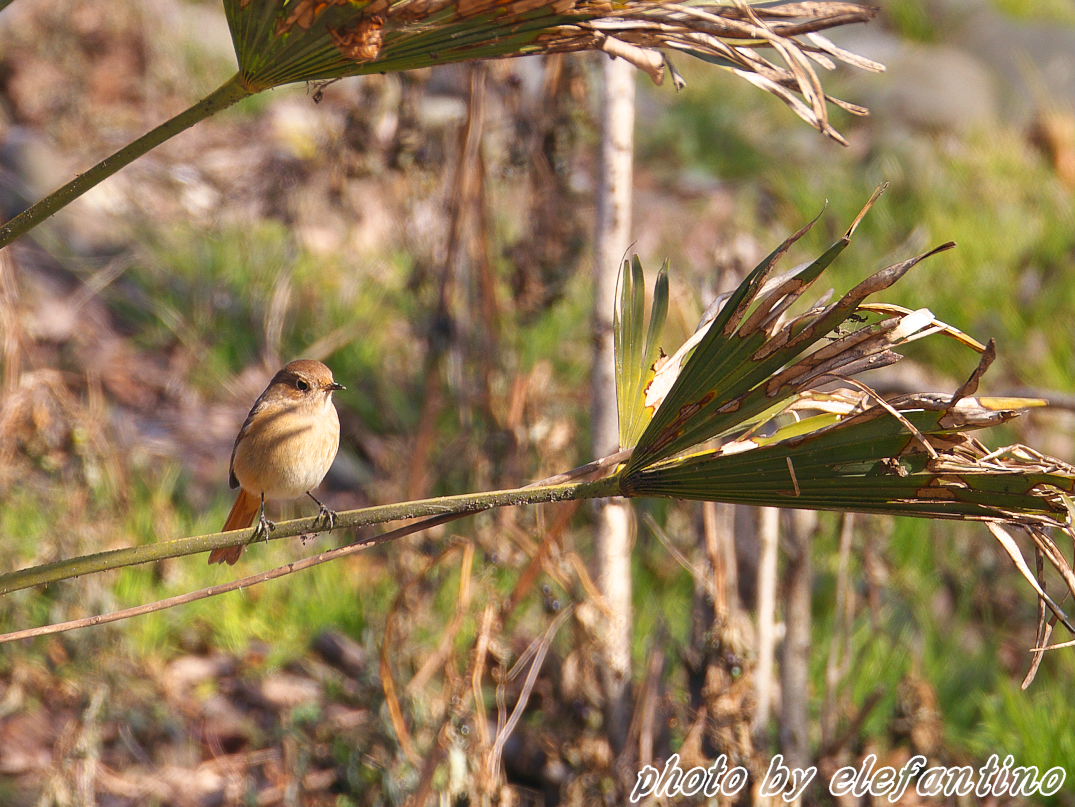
[0,73,257,247]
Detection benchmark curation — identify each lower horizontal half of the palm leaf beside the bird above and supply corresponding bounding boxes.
[624,382,1075,527]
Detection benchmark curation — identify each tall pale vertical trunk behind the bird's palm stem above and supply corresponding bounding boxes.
[591,53,634,753]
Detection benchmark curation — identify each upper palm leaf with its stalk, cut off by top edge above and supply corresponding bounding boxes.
[0,0,884,247]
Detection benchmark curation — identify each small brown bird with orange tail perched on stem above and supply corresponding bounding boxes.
[209,359,346,563]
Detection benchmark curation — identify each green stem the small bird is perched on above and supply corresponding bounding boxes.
[0,476,619,595]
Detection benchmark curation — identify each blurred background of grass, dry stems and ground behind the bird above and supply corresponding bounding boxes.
[0,0,1075,806]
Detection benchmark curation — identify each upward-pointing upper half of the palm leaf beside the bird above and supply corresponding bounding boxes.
[626,184,920,475]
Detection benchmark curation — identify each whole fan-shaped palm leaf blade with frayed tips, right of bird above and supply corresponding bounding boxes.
[617,188,1075,632]
